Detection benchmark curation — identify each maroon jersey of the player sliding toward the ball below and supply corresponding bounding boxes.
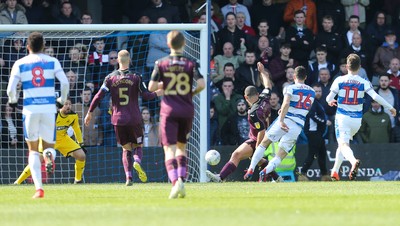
[248,89,271,141]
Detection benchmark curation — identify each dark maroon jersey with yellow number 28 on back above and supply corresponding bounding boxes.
[151,55,203,117]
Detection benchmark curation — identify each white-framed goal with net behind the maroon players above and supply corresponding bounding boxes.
[0,24,208,184]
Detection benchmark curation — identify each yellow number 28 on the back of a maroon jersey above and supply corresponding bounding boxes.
[164,72,191,95]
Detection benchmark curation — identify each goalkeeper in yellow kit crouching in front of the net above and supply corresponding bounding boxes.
[14,100,86,184]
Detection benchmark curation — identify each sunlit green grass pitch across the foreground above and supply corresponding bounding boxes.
[0,181,400,226]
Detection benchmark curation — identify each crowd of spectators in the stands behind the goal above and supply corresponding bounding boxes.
[0,0,400,146]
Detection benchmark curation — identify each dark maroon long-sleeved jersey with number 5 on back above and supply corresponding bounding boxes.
[89,70,157,126]
